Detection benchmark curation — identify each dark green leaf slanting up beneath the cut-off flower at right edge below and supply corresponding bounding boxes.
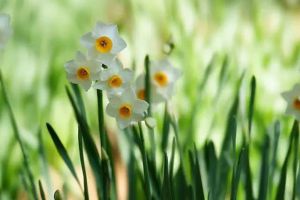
[276,120,299,200]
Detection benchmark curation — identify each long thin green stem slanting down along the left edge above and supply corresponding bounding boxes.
[0,72,38,200]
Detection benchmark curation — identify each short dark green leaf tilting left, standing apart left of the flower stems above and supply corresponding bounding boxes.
[46,123,82,189]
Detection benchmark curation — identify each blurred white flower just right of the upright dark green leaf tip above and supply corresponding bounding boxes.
[150,60,181,100]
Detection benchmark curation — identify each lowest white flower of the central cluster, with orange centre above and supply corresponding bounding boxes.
[106,88,149,129]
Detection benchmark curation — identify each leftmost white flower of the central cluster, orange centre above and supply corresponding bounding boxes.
[65,51,102,91]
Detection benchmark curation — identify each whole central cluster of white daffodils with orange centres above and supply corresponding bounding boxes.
[65,22,180,128]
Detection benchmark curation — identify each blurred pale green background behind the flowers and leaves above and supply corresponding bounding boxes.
[0,0,300,200]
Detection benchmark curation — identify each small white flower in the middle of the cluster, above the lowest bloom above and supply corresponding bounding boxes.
[93,60,133,94]
